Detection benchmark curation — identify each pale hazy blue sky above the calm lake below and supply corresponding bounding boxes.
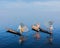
[0,0,60,14]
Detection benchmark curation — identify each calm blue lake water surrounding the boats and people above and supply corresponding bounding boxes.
[0,12,60,48]
